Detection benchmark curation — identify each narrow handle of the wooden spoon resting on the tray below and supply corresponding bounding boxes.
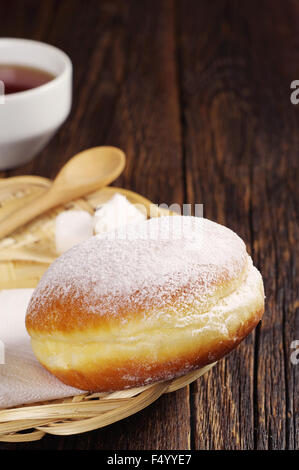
[0,190,61,239]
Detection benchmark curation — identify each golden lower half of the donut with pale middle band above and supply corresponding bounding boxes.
[27,267,264,391]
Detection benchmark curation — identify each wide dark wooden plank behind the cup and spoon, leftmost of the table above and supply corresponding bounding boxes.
[1,0,190,449]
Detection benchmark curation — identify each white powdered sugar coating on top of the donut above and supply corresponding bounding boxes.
[29,216,248,321]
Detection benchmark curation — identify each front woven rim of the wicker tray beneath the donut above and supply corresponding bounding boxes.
[0,364,214,442]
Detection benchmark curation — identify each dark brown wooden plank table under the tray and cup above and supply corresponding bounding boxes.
[0,0,299,450]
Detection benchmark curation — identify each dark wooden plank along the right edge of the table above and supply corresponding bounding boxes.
[244,1,299,449]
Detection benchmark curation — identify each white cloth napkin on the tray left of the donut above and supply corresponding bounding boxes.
[0,289,84,408]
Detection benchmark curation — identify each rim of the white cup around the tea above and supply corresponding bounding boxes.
[0,37,73,103]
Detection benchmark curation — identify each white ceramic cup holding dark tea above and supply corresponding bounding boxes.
[0,38,72,170]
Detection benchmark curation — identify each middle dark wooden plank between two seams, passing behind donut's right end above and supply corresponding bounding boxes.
[177,2,254,449]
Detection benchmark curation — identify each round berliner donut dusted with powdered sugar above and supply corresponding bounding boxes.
[26,216,264,392]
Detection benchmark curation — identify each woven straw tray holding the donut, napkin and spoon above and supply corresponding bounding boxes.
[0,176,214,442]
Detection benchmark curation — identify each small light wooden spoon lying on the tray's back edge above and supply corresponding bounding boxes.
[0,147,126,239]
